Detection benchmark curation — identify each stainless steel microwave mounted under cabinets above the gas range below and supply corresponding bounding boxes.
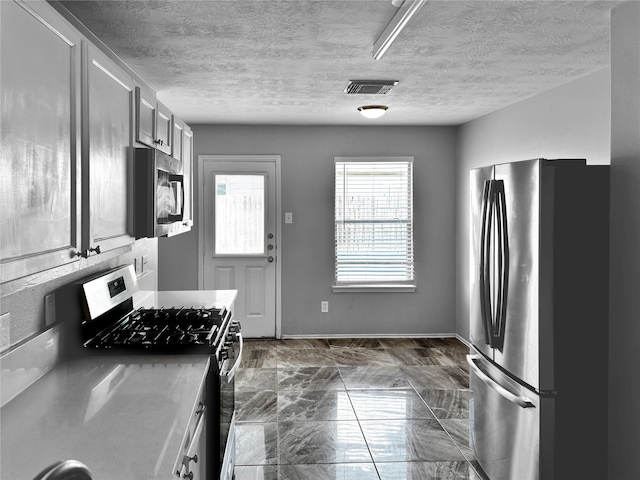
[134,148,193,238]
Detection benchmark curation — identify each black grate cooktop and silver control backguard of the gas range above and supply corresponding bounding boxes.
[80,265,240,368]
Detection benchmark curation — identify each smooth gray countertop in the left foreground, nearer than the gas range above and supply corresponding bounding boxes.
[0,354,209,480]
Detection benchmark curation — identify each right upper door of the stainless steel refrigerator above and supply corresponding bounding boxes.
[493,159,554,391]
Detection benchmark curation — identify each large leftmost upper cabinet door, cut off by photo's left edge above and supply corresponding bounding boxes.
[0,1,81,282]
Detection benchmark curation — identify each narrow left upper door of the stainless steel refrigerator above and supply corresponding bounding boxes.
[469,167,493,358]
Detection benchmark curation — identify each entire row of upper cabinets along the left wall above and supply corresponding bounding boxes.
[0,0,193,283]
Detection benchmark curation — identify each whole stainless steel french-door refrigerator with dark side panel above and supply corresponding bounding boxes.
[467,159,609,480]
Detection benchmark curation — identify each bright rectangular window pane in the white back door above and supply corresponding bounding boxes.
[214,174,265,255]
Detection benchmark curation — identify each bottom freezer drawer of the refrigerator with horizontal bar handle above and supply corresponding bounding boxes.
[467,354,554,480]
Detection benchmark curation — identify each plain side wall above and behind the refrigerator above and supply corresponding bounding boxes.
[456,69,611,339]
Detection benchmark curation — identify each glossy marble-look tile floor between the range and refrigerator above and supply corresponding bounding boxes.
[235,338,483,480]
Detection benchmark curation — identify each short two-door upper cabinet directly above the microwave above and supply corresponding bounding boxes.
[136,87,173,155]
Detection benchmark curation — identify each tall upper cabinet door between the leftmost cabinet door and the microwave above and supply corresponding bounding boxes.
[82,43,135,254]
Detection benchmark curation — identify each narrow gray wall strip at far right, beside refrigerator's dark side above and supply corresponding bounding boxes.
[609,2,640,480]
